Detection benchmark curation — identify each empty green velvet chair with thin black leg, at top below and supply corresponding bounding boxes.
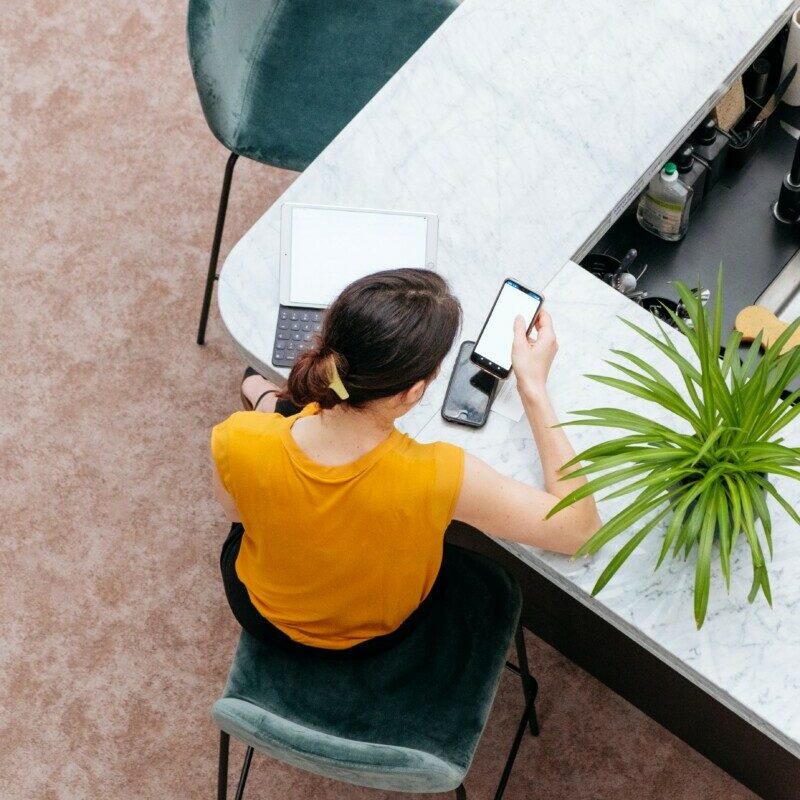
[187,0,458,344]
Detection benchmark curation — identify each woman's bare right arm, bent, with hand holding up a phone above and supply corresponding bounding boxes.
[454,310,601,554]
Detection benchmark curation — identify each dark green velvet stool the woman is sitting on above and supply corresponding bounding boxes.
[213,545,539,800]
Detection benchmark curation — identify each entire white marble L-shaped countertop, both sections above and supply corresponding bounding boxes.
[218,0,800,756]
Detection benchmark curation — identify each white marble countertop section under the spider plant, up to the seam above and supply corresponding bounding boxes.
[417,262,800,757]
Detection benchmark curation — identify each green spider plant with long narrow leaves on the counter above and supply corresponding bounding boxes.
[550,268,800,628]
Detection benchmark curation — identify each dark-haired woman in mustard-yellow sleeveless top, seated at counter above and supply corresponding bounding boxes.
[211,269,600,654]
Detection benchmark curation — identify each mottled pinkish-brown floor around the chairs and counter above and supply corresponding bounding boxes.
[0,0,764,800]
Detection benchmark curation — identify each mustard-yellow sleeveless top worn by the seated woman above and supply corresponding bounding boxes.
[211,404,464,649]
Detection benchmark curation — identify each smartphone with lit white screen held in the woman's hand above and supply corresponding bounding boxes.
[471,278,544,378]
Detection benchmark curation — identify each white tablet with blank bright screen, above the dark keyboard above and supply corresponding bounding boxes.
[280,203,439,308]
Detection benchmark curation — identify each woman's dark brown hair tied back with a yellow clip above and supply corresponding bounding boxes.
[283,269,461,408]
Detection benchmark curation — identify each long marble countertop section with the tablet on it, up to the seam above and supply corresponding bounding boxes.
[219,0,791,390]
